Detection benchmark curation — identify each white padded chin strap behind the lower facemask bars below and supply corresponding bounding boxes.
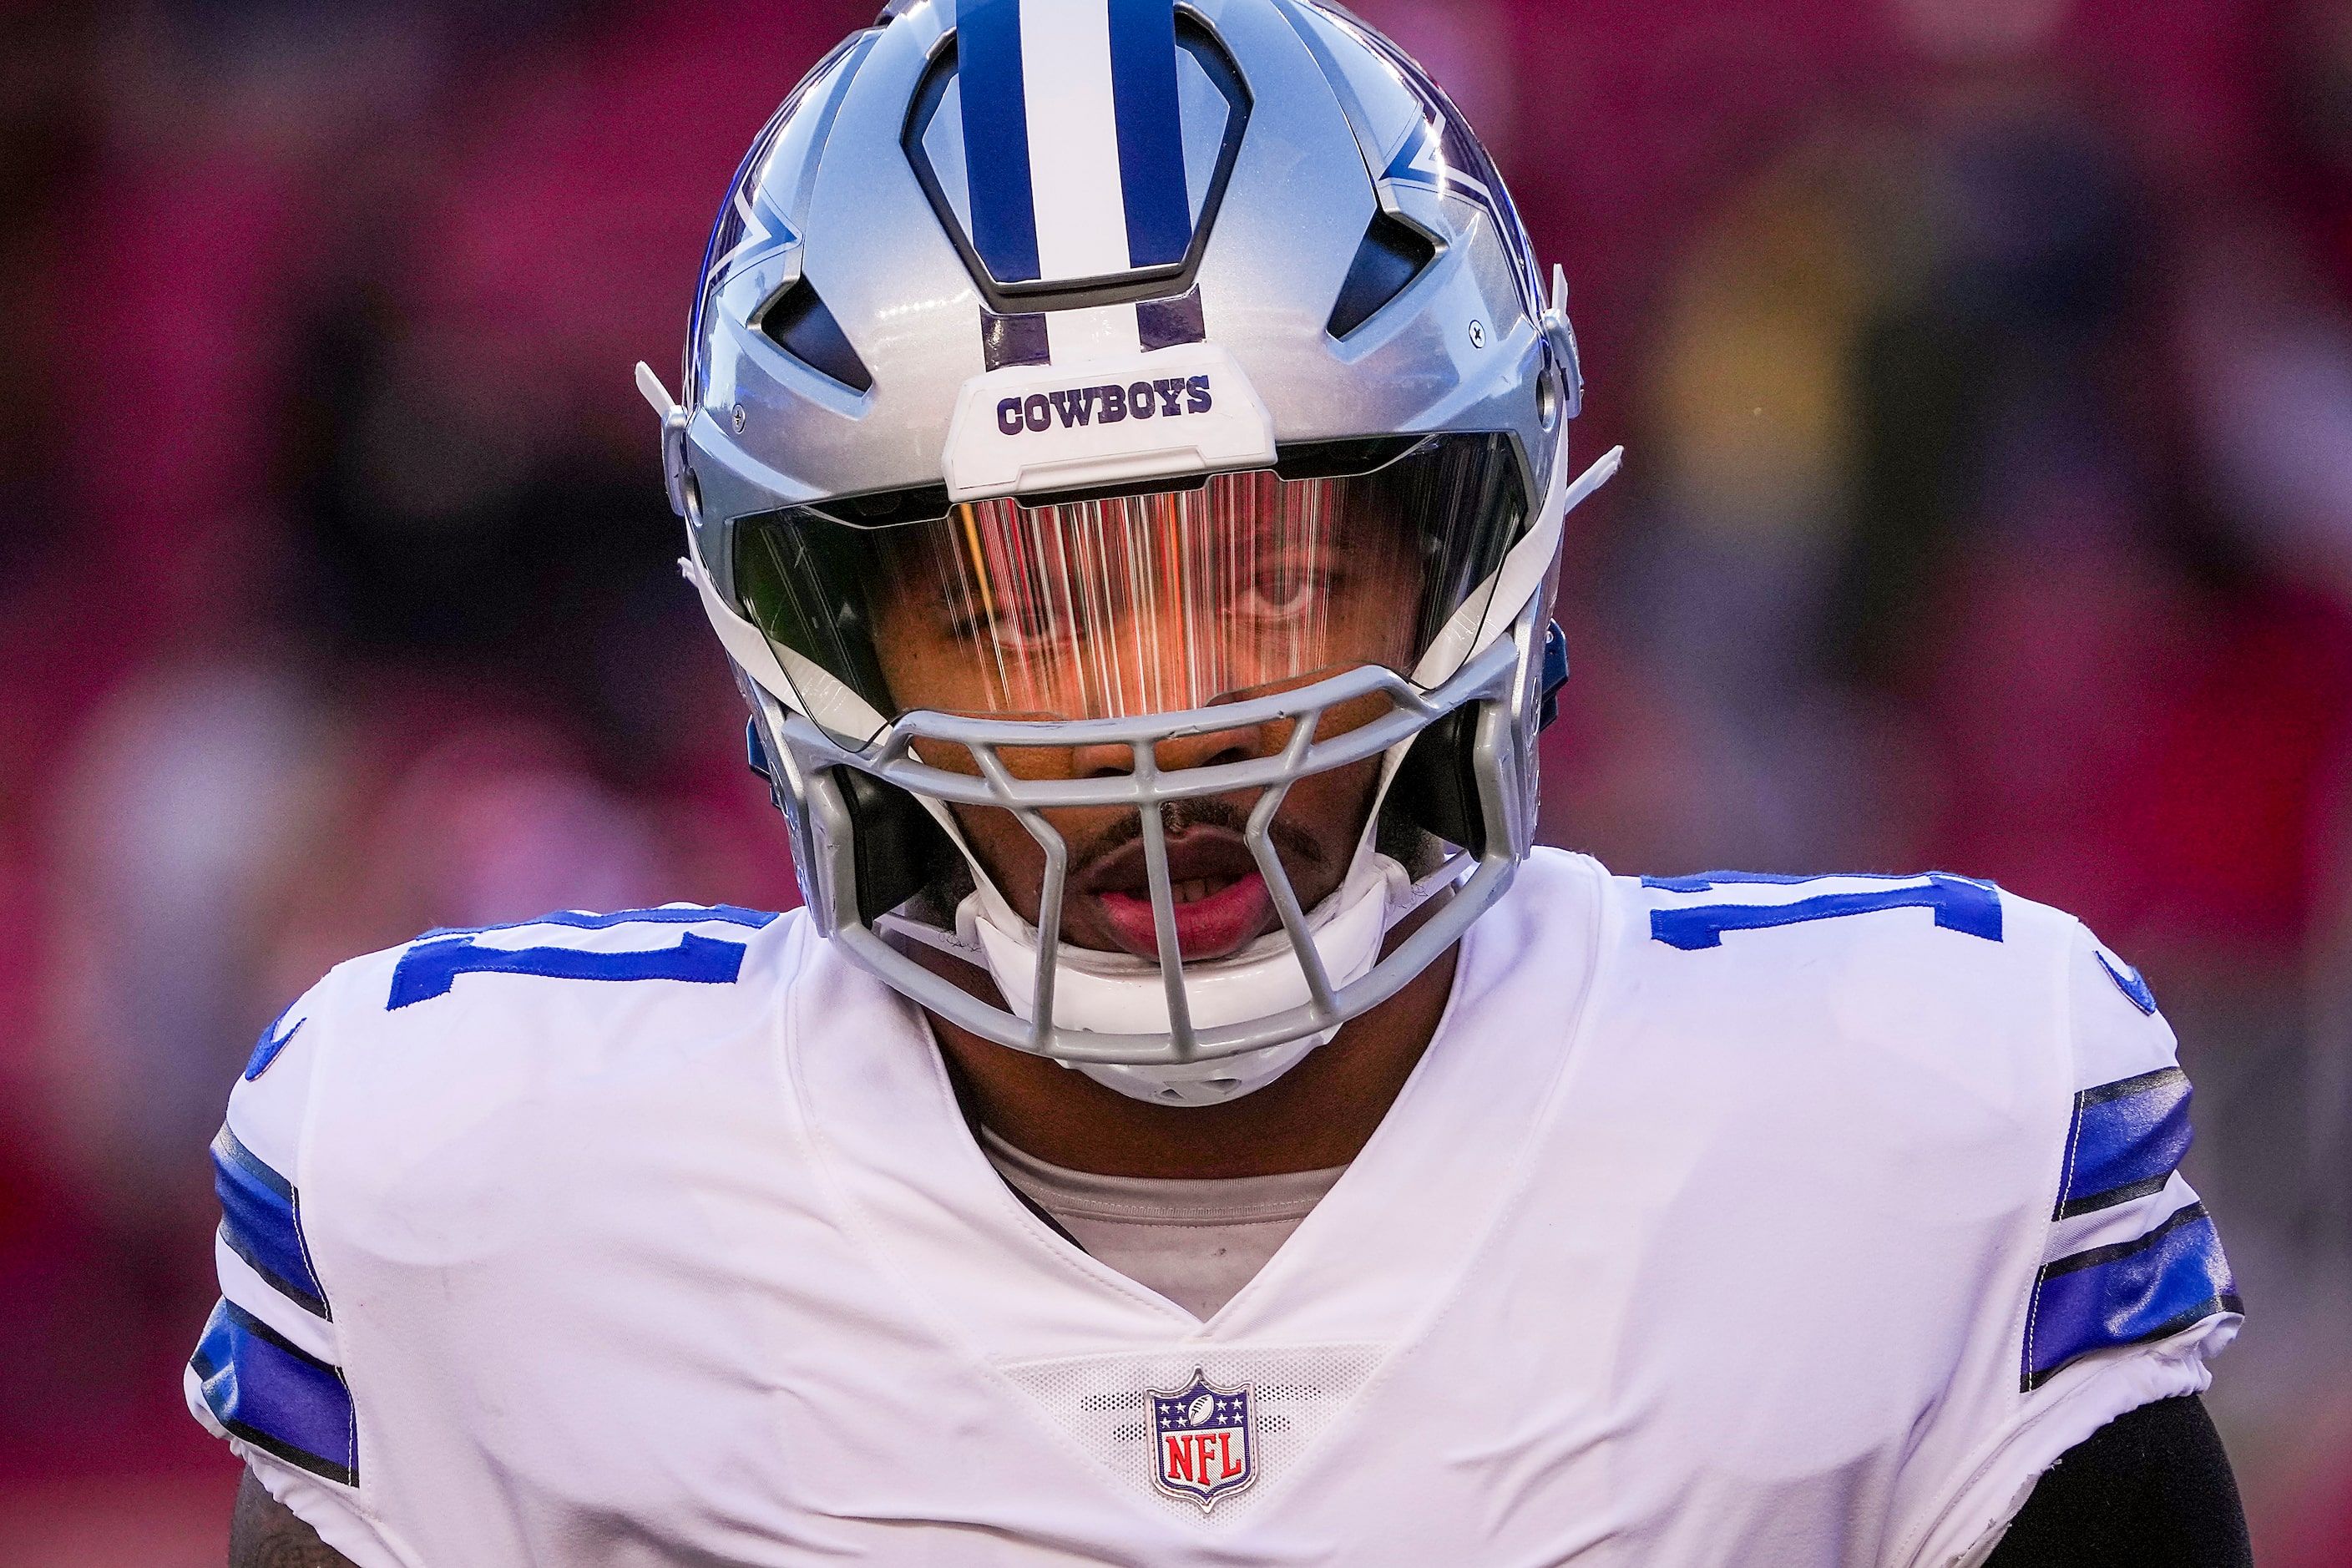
[955,853,1419,1105]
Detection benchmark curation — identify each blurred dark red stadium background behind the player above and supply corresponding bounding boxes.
[0,0,2352,1568]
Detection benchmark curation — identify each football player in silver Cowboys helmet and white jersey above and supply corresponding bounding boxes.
[202,0,2246,1568]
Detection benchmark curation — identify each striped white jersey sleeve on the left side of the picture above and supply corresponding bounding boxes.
[184,971,414,1568]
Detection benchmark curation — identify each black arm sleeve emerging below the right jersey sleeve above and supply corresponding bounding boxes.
[1985,1394,2253,1568]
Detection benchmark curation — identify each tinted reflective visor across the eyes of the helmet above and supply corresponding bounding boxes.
[734,435,1526,741]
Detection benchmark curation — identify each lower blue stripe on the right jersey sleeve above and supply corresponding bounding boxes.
[2025,1204,2242,1389]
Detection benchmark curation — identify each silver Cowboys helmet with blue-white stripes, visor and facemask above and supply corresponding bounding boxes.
[637,0,1618,1105]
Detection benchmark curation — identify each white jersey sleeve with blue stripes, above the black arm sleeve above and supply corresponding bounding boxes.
[1912,924,2243,1563]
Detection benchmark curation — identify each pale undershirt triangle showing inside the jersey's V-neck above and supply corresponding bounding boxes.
[981,1126,1348,1319]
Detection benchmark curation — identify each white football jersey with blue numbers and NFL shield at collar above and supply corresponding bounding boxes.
[188,851,2239,1568]
